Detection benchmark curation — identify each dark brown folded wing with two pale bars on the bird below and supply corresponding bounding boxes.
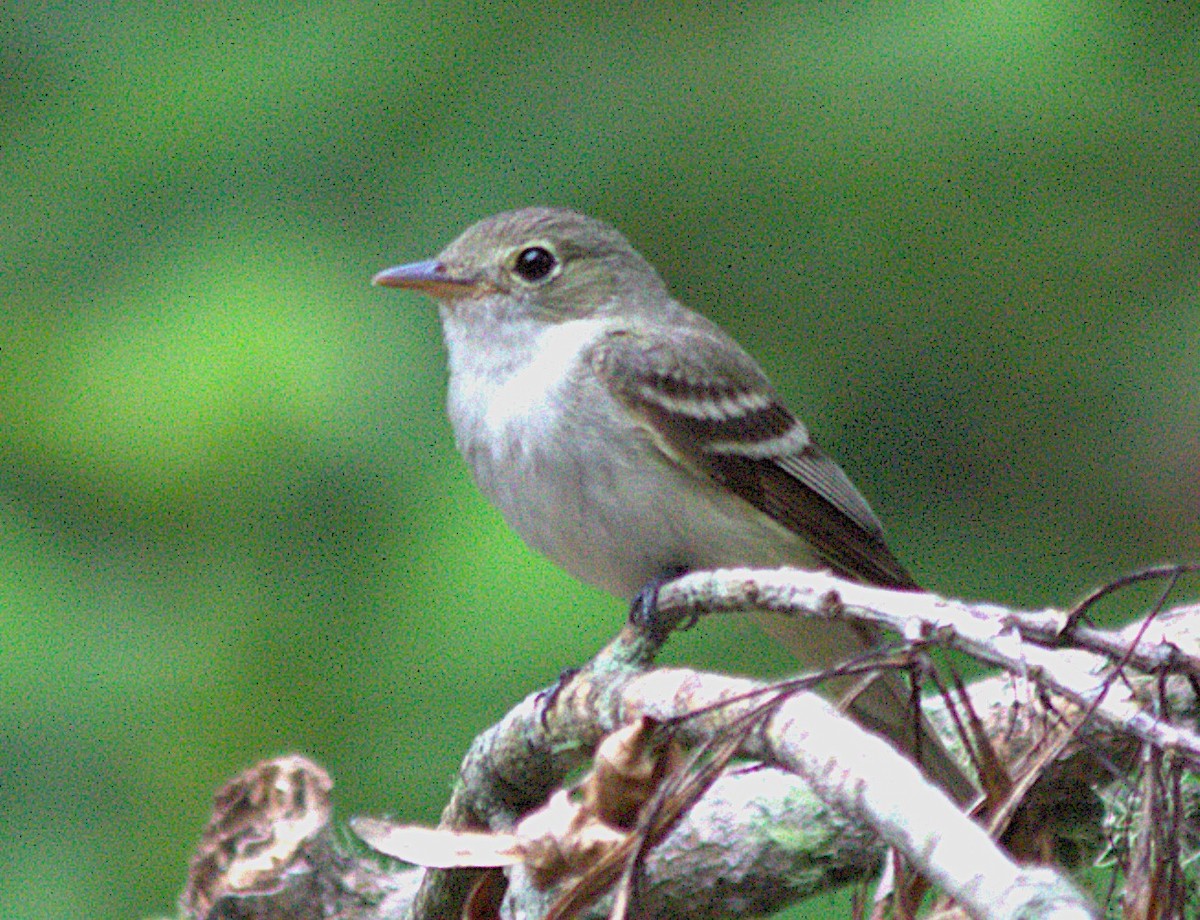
[590,324,917,588]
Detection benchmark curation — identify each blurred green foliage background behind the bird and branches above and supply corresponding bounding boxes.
[0,0,1200,920]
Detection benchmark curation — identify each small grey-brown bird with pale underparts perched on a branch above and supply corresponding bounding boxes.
[372,208,974,804]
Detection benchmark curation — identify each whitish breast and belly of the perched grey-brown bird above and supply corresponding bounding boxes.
[446,311,825,599]
